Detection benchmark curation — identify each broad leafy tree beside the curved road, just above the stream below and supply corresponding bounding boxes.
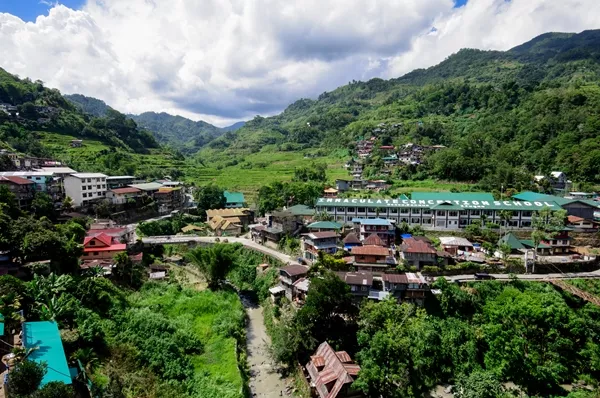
[188,243,236,289]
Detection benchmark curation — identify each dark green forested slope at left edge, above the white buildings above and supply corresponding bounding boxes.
[0,68,158,156]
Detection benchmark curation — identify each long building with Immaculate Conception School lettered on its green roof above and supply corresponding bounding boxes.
[316,192,568,231]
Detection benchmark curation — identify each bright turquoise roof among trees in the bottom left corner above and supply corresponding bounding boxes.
[23,321,71,386]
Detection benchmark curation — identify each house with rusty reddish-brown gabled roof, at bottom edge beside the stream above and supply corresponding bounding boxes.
[306,342,363,398]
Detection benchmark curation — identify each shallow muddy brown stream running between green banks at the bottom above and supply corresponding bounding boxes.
[246,307,289,398]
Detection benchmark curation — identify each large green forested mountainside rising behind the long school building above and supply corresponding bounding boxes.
[200,30,600,189]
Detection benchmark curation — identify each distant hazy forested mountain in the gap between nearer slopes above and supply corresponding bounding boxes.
[130,112,224,152]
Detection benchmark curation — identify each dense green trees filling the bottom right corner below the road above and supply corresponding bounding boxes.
[355,280,600,397]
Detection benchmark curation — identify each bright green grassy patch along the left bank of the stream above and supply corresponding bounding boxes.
[132,283,245,398]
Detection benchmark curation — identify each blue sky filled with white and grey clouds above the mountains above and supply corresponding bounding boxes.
[0,0,600,126]
